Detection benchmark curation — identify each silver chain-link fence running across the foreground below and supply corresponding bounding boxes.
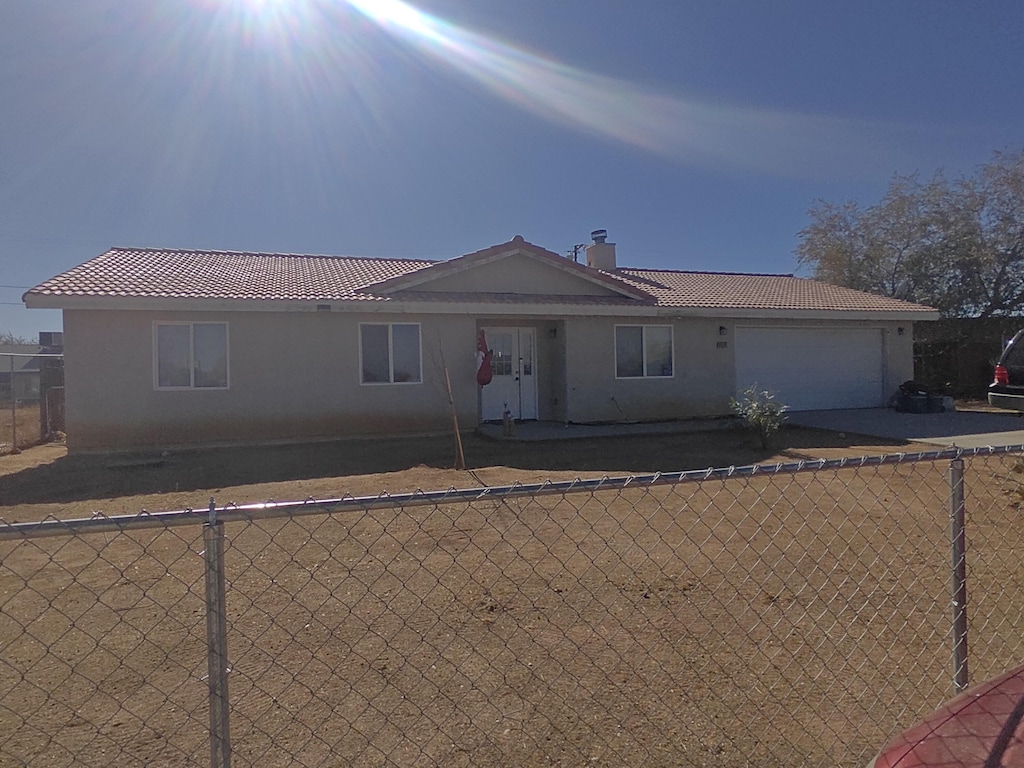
[0,446,1024,768]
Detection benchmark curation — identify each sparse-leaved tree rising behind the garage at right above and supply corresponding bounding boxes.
[797,152,1024,316]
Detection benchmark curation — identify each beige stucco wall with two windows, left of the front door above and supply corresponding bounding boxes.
[65,310,476,451]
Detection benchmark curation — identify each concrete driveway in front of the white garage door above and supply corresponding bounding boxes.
[787,408,1024,449]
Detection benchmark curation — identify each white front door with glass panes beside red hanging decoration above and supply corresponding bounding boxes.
[480,328,537,421]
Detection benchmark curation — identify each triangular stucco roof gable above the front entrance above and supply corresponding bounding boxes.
[361,234,651,301]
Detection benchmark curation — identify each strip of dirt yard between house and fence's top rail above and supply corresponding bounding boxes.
[0,427,905,521]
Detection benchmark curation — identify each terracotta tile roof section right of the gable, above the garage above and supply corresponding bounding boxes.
[614,268,935,313]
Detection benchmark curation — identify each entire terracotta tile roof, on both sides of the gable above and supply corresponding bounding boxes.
[26,239,935,314]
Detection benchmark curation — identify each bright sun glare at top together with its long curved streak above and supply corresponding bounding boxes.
[182,0,905,179]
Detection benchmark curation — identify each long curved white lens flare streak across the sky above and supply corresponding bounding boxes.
[346,0,912,176]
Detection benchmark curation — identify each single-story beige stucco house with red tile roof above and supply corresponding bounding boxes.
[25,230,938,451]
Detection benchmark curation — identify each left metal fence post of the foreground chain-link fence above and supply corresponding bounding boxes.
[203,499,231,768]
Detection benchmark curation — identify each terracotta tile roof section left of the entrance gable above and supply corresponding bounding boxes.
[29,248,434,301]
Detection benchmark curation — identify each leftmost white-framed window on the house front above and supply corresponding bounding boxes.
[155,323,227,389]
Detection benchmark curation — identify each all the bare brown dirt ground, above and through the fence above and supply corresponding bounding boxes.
[8,428,1024,768]
